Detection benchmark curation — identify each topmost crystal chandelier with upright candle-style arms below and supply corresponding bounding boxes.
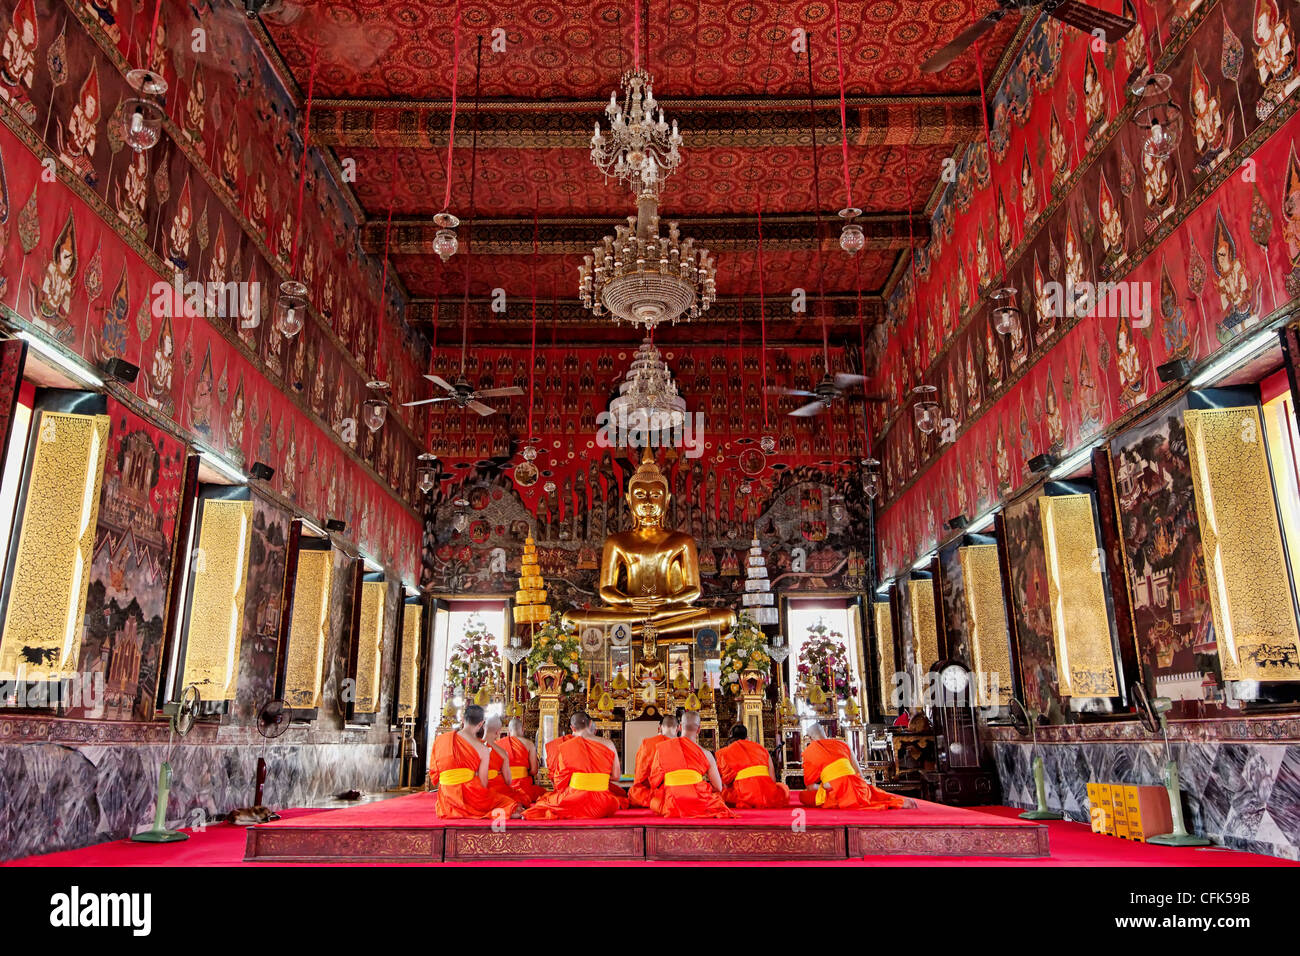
[592,68,681,196]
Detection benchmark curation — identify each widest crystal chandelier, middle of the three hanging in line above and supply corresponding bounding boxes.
[579,193,718,332]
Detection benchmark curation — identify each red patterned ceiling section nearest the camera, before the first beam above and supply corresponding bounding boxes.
[267,0,1021,99]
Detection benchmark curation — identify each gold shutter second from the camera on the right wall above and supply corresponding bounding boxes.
[1039,494,1119,697]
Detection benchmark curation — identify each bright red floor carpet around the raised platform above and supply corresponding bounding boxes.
[4,800,1297,866]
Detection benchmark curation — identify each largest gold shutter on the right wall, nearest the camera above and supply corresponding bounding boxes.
[1184,406,1300,680]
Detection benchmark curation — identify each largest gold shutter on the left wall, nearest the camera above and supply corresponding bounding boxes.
[0,411,108,680]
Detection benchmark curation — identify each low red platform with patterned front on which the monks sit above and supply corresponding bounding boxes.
[244,793,1049,862]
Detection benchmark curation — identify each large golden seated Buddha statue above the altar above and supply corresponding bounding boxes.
[564,449,736,643]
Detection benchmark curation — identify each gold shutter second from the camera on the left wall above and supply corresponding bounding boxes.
[182,498,252,700]
